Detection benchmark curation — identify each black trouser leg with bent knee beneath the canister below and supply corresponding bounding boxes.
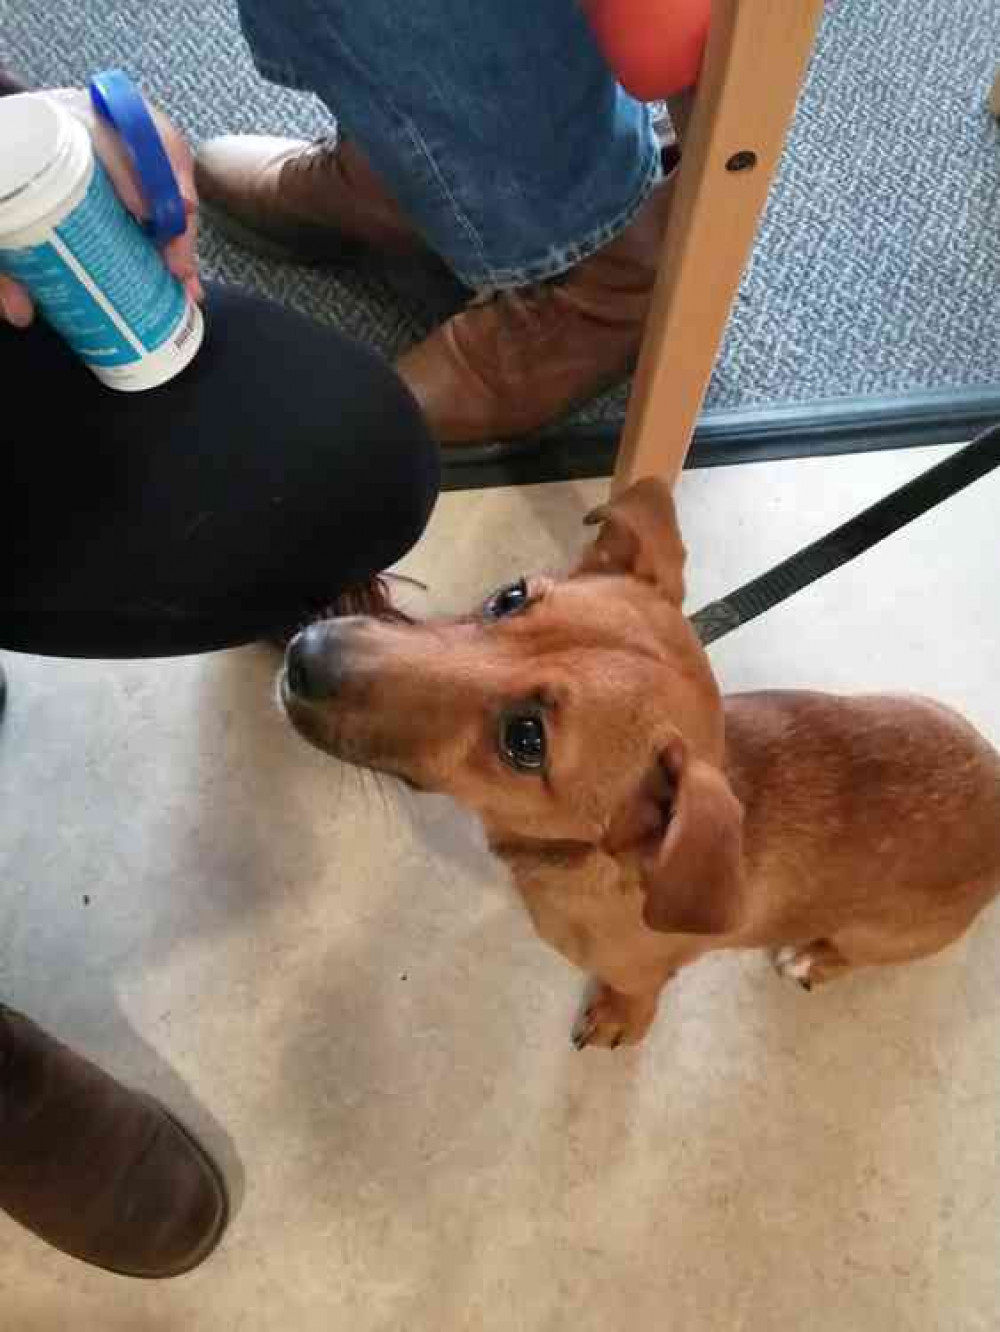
[0,286,438,657]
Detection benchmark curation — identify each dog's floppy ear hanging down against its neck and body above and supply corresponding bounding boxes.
[643,737,744,934]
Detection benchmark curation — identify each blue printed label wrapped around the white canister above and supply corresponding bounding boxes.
[0,163,186,366]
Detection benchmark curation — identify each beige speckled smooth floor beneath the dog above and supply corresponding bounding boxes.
[0,452,1000,1332]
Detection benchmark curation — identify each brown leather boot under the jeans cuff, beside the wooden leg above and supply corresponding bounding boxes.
[395,167,672,444]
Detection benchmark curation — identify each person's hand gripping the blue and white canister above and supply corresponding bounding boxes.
[0,88,204,328]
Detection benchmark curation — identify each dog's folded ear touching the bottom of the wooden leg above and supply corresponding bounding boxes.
[579,477,686,606]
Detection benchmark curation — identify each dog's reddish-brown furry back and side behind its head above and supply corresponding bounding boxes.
[726,691,1000,963]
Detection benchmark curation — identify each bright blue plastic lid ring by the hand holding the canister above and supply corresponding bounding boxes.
[91,69,188,244]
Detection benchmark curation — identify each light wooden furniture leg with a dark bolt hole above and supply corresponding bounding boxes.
[613,0,823,492]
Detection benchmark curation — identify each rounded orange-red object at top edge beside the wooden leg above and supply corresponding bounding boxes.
[582,0,711,101]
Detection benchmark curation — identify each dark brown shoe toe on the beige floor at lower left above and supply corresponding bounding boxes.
[0,1004,229,1277]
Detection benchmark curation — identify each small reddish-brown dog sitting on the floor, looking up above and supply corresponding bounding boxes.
[280,481,1000,1047]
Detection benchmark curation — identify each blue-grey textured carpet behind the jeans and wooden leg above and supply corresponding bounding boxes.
[0,0,1000,417]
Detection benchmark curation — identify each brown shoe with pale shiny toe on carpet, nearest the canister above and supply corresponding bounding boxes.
[194,135,426,264]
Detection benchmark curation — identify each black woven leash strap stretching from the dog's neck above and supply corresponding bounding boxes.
[691,415,1000,647]
